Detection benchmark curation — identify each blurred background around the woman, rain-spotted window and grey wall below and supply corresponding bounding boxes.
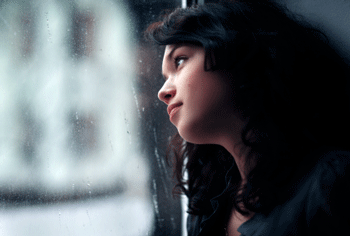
[0,0,350,236]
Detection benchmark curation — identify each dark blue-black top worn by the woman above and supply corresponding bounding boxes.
[187,148,350,236]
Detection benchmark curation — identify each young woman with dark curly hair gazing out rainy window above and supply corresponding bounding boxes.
[146,1,350,236]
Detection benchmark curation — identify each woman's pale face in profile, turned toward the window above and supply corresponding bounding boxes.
[158,44,245,144]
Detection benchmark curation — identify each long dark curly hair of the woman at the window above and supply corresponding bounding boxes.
[145,1,350,217]
